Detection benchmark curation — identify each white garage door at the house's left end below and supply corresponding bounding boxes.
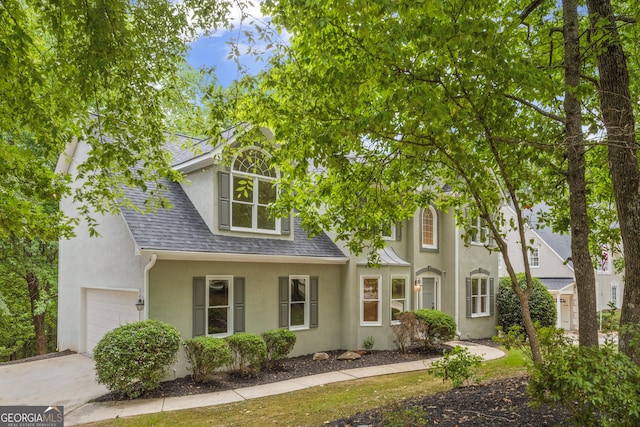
[85,289,140,353]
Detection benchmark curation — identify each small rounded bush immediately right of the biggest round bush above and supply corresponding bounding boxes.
[184,336,231,383]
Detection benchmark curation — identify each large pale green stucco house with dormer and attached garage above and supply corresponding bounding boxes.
[58,131,498,375]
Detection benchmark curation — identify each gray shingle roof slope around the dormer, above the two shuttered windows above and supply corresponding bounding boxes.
[123,181,345,258]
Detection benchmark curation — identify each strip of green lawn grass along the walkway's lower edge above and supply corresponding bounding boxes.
[82,350,526,427]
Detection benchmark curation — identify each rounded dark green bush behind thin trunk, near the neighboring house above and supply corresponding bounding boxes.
[497,273,557,331]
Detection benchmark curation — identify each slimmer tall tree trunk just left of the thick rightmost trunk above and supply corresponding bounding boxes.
[562,0,598,347]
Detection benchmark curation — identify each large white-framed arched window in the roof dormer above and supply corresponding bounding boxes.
[230,148,280,232]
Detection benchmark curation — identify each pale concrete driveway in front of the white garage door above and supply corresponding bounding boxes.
[0,354,108,414]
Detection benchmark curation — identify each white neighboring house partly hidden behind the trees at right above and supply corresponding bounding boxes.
[500,205,623,330]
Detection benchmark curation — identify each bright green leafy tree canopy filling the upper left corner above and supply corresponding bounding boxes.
[0,0,229,238]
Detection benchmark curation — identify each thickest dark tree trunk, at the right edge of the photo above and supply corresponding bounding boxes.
[587,0,640,362]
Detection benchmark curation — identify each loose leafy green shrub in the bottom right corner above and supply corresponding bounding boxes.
[529,342,640,426]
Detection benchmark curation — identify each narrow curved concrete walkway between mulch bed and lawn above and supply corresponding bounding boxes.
[64,342,504,426]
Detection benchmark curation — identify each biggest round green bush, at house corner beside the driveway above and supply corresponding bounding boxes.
[93,320,180,399]
